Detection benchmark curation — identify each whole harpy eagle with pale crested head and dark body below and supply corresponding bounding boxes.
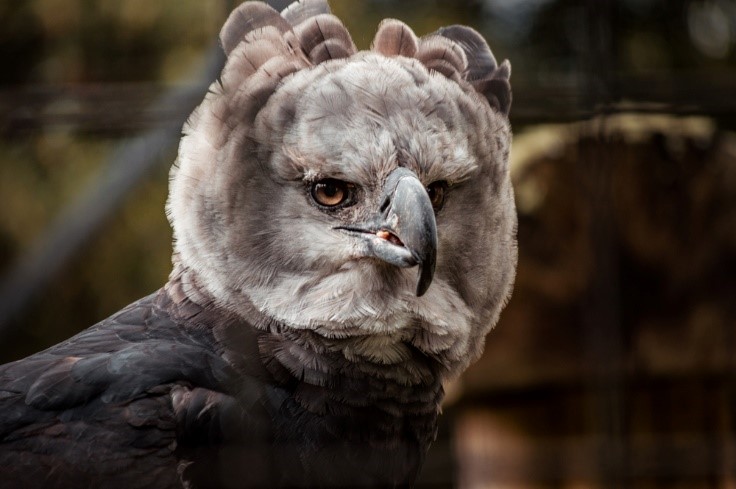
[0,0,517,488]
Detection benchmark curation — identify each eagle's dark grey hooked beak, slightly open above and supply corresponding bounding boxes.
[337,168,437,297]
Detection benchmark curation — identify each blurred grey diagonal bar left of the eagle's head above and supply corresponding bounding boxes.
[0,46,224,336]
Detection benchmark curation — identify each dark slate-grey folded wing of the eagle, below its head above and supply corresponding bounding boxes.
[0,292,250,488]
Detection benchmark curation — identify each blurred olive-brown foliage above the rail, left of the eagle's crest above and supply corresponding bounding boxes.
[0,0,229,85]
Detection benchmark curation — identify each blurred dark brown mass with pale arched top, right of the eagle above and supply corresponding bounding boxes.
[454,115,736,488]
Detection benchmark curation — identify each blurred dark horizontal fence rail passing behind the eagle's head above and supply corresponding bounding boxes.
[0,74,736,133]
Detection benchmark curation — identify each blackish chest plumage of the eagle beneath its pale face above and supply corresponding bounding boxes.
[247,331,443,487]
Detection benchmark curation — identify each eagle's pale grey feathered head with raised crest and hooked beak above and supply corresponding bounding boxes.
[167,0,517,374]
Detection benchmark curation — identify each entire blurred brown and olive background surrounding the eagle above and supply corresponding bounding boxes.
[0,0,736,489]
